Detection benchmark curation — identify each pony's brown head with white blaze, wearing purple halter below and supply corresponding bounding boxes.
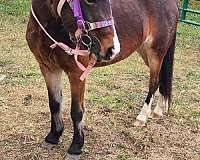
[57,0,120,61]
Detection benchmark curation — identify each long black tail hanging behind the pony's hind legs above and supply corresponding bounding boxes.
[159,34,176,106]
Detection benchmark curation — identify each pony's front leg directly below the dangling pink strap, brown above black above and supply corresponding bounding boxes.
[68,73,85,155]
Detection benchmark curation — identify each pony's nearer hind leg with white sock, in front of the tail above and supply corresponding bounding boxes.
[134,49,162,127]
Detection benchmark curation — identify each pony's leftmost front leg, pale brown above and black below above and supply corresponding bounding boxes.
[40,64,64,147]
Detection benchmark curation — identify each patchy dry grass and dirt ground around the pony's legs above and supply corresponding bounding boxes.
[0,1,200,160]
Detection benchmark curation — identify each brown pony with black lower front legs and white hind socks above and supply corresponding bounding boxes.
[26,0,179,158]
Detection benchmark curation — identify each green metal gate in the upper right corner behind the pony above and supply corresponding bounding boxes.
[180,0,200,26]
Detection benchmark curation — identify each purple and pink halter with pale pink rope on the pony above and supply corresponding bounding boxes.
[31,0,114,81]
